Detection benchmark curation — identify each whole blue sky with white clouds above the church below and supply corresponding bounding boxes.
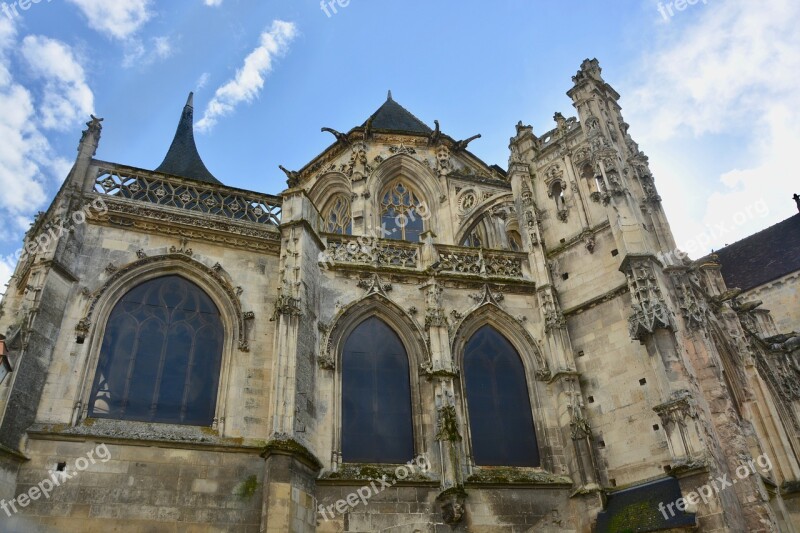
[0,0,800,291]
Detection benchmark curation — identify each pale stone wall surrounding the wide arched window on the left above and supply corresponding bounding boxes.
[26,218,277,439]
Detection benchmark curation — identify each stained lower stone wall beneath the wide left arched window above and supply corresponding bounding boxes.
[8,439,264,533]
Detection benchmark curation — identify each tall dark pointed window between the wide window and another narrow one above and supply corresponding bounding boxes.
[342,317,414,463]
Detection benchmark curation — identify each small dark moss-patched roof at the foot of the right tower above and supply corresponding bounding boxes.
[596,477,696,533]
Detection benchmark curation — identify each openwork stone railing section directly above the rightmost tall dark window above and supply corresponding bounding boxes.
[436,246,525,279]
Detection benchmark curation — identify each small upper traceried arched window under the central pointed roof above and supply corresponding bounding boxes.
[380,181,427,242]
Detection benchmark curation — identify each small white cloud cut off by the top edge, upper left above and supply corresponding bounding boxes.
[68,0,152,40]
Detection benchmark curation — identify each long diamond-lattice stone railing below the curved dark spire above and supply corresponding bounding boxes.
[94,161,281,226]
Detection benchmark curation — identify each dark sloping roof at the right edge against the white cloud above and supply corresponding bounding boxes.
[714,213,800,291]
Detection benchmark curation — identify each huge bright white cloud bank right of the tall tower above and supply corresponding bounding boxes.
[621,0,800,255]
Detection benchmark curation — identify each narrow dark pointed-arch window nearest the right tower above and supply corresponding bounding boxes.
[464,325,539,466]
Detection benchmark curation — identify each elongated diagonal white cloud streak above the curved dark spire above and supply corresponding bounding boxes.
[197,20,297,131]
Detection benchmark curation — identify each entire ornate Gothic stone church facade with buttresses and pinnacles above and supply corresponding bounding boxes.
[0,60,800,532]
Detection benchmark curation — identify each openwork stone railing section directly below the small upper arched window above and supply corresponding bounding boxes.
[327,235,419,268]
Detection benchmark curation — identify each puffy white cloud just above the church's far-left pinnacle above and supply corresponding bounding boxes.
[21,35,94,130]
